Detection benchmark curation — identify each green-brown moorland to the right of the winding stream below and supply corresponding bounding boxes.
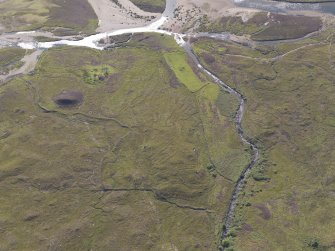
[193,28,335,251]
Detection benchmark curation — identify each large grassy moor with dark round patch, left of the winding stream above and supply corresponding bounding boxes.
[0,35,249,250]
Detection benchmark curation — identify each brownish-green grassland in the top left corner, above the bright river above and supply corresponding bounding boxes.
[0,0,98,35]
